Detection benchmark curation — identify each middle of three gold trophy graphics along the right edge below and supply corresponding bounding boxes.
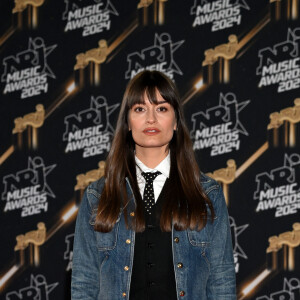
[268,98,300,148]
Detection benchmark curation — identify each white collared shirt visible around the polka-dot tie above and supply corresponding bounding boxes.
[135,151,171,202]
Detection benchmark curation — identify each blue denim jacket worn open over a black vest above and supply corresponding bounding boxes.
[72,175,236,300]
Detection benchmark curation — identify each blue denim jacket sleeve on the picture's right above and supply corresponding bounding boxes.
[206,186,236,300]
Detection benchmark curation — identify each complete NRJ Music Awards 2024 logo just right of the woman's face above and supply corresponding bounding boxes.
[191,93,250,156]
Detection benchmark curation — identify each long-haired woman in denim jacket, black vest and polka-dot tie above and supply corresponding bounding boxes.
[72,71,236,300]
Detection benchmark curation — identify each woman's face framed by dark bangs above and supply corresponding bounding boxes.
[128,91,176,151]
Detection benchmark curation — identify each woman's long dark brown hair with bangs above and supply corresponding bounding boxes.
[95,71,214,232]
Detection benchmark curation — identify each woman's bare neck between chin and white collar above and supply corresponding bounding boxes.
[135,147,169,169]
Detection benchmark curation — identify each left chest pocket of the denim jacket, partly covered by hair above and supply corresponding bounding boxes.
[89,208,120,251]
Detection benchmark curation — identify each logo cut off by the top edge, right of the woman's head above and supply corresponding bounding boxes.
[191,0,250,31]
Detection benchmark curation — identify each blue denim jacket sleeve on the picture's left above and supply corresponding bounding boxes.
[71,188,100,300]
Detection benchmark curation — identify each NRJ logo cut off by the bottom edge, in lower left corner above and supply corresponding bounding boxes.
[6,274,58,300]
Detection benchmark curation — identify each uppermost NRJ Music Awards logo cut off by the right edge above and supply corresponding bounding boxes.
[256,27,300,93]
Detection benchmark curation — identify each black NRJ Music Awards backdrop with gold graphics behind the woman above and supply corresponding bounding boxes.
[0,0,300,300]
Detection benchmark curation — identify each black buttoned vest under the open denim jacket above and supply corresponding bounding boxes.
[129,179,177,300]
